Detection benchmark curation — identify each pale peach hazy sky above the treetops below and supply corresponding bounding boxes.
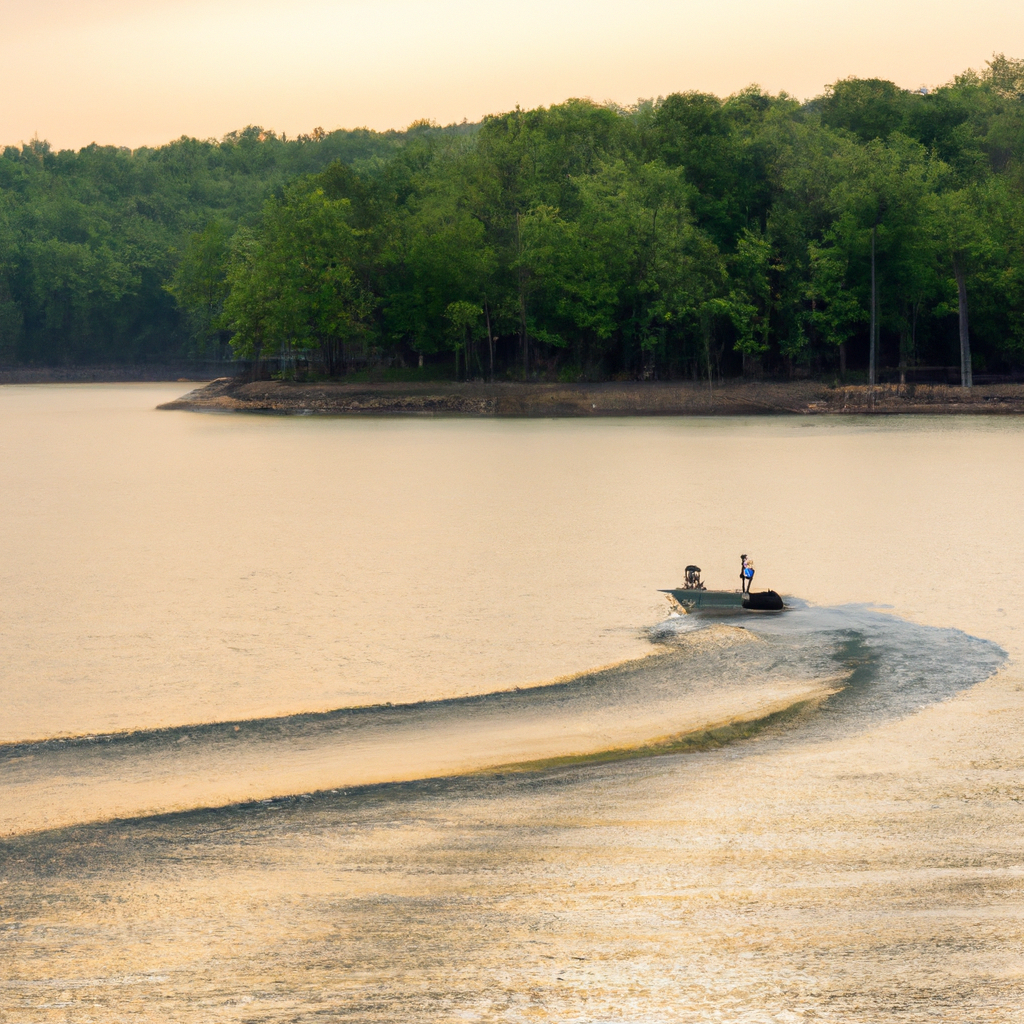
[6,0,1024,147]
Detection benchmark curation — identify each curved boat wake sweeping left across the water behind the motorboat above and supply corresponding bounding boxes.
[0,598,1006,836]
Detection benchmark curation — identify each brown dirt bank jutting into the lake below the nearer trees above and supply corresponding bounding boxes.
[153,378,1024,417]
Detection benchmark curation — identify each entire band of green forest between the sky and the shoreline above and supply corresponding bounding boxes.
[0,55,1024,380]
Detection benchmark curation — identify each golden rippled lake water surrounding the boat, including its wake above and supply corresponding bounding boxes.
[0,384,1024,1022]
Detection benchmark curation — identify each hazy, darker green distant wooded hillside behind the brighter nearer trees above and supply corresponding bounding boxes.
[0,128,403,364]
